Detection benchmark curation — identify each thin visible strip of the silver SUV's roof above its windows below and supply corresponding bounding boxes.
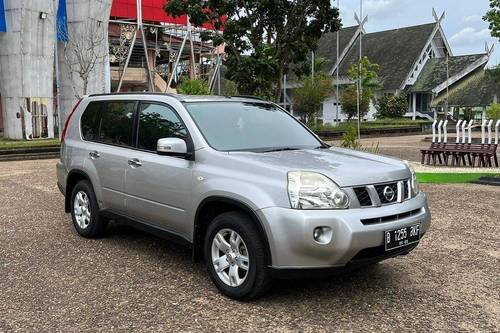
[88,92,268,103]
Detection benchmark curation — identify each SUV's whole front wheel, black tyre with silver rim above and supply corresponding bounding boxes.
[204,211,271,301]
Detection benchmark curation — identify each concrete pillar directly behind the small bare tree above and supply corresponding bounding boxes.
[58,0,112,132]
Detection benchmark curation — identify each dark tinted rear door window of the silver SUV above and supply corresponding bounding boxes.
[97,101,136,146]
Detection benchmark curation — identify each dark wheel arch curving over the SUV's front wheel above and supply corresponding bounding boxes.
[193,196,272,265]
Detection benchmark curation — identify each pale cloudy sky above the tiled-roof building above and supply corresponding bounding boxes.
[338,0,500,66]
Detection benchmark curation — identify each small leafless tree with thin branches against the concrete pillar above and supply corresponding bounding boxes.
[64,20,107,99]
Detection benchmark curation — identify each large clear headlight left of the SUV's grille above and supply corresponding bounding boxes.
[288,171,349,209]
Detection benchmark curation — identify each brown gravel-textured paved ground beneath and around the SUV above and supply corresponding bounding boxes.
[0,160,500,332]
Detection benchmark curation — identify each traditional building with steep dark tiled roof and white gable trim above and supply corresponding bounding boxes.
[308,14,495,123]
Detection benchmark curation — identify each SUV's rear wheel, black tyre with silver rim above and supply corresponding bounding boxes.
[70,180,108,238]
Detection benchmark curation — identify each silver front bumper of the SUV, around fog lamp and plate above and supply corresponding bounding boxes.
[257,192,431,270]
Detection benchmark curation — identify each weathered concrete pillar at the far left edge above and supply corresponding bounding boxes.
[0,0,57,139]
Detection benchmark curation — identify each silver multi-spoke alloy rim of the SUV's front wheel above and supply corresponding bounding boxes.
[212,228,250,287]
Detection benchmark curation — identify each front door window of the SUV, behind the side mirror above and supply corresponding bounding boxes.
[137,103,187,151]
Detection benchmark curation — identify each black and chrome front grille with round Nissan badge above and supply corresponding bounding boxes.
[352,179,411,207]
